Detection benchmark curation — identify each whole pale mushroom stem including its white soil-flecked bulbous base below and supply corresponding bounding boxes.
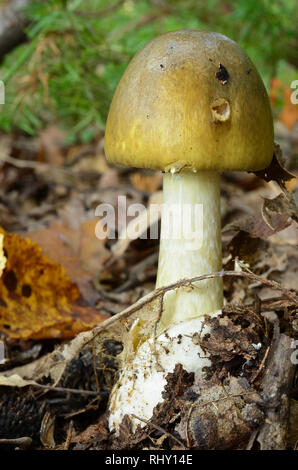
[109,171,223,431]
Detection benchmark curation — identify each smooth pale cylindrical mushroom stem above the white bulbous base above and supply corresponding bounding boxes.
[156,171,223,328]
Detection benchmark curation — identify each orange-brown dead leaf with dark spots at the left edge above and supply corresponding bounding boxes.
[0,229,105,340]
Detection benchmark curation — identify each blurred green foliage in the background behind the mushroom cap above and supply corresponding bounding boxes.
[0,0,297,142]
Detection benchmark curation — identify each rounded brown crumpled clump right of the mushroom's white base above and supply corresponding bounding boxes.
[175,376,264,450]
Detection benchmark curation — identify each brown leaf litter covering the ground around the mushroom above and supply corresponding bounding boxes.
[0,129,298,449]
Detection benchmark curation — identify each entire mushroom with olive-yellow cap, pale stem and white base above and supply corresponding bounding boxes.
[105,30,273,431]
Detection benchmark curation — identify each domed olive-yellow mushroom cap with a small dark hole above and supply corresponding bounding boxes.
[105,30,273,171]
